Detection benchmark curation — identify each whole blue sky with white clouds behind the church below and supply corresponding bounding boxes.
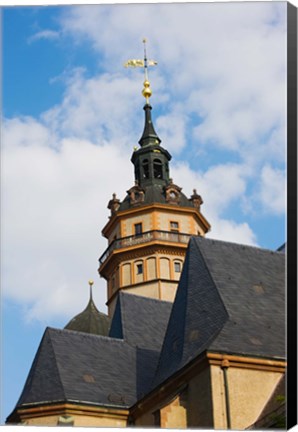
[1,2,287,421]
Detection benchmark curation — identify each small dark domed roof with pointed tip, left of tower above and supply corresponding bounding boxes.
[64,296,110,336]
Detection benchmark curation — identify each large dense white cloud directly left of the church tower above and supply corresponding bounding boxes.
[2,119,132,320]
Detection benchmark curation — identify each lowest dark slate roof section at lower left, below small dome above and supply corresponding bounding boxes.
[17,328,136,408]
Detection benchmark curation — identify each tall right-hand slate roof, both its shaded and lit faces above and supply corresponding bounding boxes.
[153,237,285,387]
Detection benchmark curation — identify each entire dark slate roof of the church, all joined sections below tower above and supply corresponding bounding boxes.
[8,237,285,418]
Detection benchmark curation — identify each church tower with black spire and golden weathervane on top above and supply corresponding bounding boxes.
[99,40,210,316]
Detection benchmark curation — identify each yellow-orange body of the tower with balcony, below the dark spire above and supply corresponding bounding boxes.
[99,203,210,315]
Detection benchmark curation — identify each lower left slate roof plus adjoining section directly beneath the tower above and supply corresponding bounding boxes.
[11,293,172,416]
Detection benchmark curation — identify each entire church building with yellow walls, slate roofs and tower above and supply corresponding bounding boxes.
[7,42,286,430]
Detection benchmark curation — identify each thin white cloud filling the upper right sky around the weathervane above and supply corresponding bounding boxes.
[61,2,286,165]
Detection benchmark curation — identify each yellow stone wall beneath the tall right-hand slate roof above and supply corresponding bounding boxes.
[132,354,286,430]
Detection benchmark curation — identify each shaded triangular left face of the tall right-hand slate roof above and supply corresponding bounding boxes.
[153,238,228,386]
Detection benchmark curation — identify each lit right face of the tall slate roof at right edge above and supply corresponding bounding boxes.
[203,239,286,359]
